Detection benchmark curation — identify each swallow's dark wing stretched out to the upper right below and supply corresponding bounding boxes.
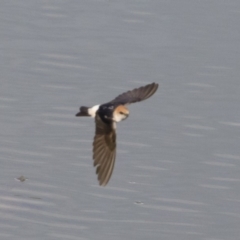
[110,83,158,105]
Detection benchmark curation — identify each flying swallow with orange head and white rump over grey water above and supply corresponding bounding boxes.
[76,83,158,186]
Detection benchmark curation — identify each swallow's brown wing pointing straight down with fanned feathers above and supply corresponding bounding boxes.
[93,115,116,186]
